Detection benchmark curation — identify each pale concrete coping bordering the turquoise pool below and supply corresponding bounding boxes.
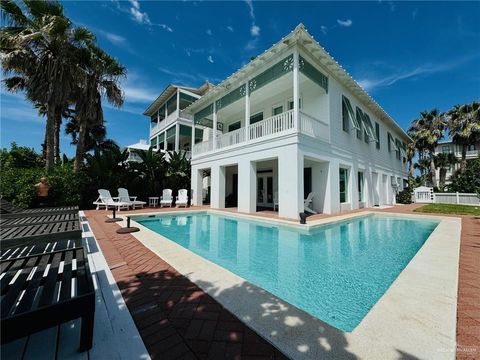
[120,209,461,359]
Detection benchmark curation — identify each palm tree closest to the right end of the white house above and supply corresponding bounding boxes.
[409,109,445,187]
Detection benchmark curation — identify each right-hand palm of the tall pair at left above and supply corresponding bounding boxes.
[74,44,126,172]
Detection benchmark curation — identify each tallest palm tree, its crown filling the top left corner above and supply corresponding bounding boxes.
[0,0,94,171]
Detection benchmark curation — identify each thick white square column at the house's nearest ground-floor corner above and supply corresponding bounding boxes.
[278,145,304,219]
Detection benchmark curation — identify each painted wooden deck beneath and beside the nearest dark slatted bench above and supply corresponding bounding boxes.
[1,213,149,360]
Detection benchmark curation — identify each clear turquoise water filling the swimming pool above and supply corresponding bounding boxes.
[134,213,438,331]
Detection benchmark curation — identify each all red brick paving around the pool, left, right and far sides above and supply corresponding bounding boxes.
[86,204,480,360]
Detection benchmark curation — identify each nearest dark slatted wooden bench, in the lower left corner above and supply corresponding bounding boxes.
[0,247,95,351]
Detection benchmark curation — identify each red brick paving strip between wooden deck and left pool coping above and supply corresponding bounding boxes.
[86,211,287,360]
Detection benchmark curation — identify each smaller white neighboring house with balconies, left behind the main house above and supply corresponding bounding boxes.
[143,82,212,159]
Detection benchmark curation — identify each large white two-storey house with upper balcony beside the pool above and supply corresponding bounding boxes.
[185,24,410,219]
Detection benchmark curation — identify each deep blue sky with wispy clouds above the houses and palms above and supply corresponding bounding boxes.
[0,0,480,156]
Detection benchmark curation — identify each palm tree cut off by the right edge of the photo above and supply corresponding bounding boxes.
[448,101,480,174]
